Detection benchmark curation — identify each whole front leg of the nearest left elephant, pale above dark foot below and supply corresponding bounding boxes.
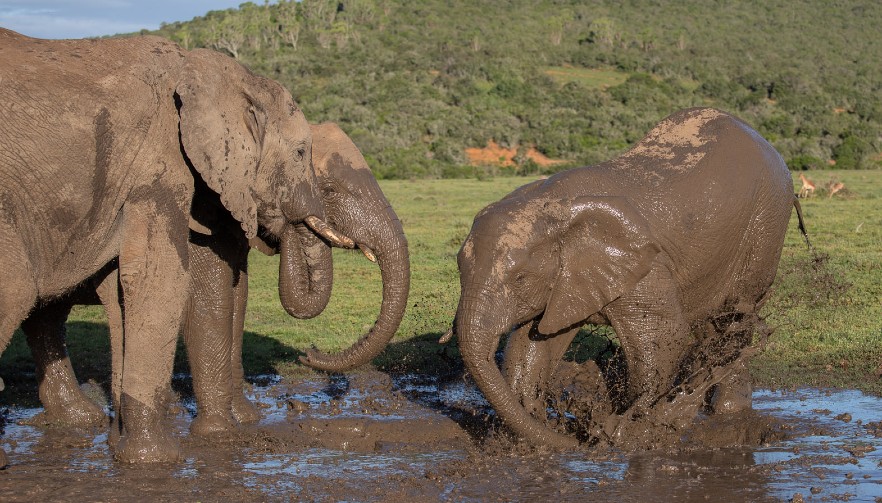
[115,192,192,462]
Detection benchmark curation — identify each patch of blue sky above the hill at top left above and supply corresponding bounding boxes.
[0,0,248,38]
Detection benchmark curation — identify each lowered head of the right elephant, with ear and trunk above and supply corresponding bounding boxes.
[454,185,659,446]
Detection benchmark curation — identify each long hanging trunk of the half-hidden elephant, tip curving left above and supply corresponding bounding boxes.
[300,221,410,372]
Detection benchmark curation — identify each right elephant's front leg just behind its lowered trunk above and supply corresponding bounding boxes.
[502,322,579,419]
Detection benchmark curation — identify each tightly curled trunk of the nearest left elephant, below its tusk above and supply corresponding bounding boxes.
[279,224,334,319]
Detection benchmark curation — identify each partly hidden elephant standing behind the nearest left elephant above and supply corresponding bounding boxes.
[22,123,410,440]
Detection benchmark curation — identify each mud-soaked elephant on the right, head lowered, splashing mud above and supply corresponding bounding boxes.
[454,108,795,447]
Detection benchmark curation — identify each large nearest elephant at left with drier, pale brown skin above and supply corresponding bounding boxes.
[0,30,348,462]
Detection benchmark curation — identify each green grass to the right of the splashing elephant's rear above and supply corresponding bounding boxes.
[754,171,882,394]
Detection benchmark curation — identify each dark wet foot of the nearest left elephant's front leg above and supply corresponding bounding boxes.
[114,395,183,463]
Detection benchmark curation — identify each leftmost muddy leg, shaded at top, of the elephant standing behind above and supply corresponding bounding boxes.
[21,302,107,426]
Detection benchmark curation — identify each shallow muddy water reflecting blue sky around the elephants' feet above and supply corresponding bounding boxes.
[0,382,882,501]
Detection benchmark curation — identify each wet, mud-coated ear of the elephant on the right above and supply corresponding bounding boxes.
[539,197,660,335]
